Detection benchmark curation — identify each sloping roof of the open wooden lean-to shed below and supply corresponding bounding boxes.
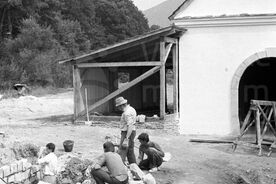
[59,25,186,64]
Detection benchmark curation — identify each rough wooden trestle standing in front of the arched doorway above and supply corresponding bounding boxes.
[232,100,276,156]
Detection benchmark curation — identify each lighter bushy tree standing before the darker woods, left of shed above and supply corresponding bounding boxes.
[6,18,68,86]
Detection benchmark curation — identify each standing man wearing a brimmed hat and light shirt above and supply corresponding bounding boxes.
[115,97,137,164]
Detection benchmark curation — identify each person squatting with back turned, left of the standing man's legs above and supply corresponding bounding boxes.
[86,142,128,184]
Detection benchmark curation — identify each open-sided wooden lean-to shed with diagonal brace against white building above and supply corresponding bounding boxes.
[59,26,186,120]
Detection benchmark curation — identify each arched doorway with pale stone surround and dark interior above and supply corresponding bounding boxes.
[231,48,276,129]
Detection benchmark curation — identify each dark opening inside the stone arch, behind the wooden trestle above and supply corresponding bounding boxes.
[239,57,276,122]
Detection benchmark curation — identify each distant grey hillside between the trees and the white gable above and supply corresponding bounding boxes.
[143,0,184,27]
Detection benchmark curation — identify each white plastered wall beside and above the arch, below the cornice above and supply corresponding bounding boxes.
[179,25,276,135]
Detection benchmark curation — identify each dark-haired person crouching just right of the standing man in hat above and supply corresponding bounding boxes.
[138,133,165,172]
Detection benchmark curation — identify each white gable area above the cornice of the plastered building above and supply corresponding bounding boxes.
[169,0,276,20]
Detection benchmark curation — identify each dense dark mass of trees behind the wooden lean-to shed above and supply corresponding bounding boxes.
[0,0,149,89]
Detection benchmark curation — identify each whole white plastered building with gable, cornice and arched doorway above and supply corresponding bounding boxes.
[170,0,276,135]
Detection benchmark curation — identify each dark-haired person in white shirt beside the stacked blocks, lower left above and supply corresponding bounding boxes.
[38,143,57,184]
